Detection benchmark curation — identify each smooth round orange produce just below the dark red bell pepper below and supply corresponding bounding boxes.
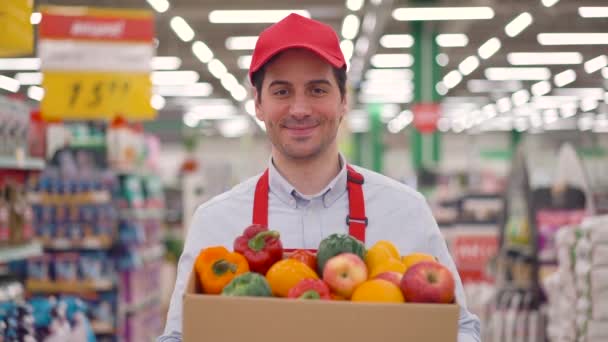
[266,259,319,297]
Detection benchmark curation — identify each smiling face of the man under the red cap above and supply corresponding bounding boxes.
[256,49,346,160]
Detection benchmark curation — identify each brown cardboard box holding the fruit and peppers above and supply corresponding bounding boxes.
[182,272,459,342]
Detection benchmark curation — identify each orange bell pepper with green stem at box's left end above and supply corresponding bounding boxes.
[194,246,249,294]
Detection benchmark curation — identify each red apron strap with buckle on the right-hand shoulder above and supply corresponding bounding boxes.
[346,165,367,243]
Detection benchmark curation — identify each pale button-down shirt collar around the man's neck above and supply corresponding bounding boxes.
[268,154,347,208]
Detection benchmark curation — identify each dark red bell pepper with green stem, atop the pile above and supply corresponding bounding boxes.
[234,224,283,274]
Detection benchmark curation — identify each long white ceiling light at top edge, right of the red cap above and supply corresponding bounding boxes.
[393,7,494,21]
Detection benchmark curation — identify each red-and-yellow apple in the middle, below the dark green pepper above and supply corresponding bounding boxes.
[323,253,367,299]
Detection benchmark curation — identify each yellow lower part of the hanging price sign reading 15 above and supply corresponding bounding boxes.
[40,71,156,120]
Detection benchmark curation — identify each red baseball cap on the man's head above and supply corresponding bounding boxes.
[249,13,346,83]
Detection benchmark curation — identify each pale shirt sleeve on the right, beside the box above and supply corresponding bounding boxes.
[420,195,481,342]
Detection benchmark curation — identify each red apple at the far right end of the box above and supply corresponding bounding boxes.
[401,261,454,303]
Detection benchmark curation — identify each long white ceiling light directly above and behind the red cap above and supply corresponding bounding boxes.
[209,10,310,24]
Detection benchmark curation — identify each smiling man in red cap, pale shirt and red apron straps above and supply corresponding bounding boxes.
[159,14,479,342]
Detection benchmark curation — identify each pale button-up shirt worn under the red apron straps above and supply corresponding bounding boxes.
[158,156,480,342]
